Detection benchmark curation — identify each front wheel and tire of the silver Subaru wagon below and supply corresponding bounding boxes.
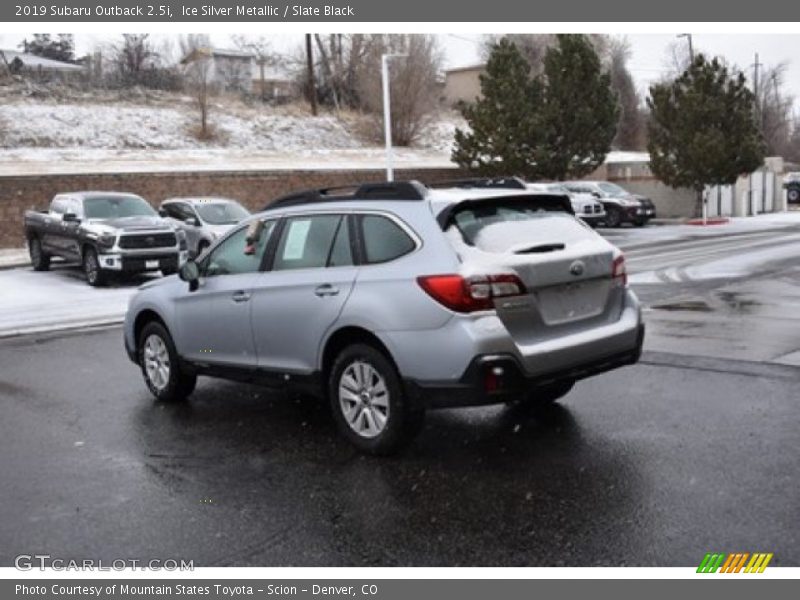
[137,321,197,402]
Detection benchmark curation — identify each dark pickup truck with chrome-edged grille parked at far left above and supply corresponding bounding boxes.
[25,192,187,286]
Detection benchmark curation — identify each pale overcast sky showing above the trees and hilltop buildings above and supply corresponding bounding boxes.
[0,33,800,107]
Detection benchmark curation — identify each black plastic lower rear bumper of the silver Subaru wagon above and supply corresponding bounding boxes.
[405,324,644,408]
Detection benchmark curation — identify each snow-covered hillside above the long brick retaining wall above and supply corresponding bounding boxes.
[0,97,463,174]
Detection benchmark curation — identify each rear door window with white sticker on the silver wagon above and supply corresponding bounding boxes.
[272,215,343,271]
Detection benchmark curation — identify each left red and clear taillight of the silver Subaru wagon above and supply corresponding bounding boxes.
[417,274,527,312]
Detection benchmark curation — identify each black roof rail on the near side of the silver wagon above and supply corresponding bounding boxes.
[264,180,427,210]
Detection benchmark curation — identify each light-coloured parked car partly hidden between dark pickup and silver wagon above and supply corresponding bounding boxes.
[158,197,250,256]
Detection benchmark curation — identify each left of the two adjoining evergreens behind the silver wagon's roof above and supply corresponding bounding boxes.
[452,39,542,178]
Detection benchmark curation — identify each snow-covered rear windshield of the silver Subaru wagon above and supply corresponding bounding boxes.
[451,198,587,251]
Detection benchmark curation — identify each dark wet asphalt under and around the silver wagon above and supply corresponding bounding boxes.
[0,328,800,566]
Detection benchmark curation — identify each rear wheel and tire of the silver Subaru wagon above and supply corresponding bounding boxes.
[328,344,425,455]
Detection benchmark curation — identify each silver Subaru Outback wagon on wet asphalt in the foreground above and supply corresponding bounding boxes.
[125,180,644,453]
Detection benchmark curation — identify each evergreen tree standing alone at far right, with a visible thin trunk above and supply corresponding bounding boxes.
[647,54,765,216]
